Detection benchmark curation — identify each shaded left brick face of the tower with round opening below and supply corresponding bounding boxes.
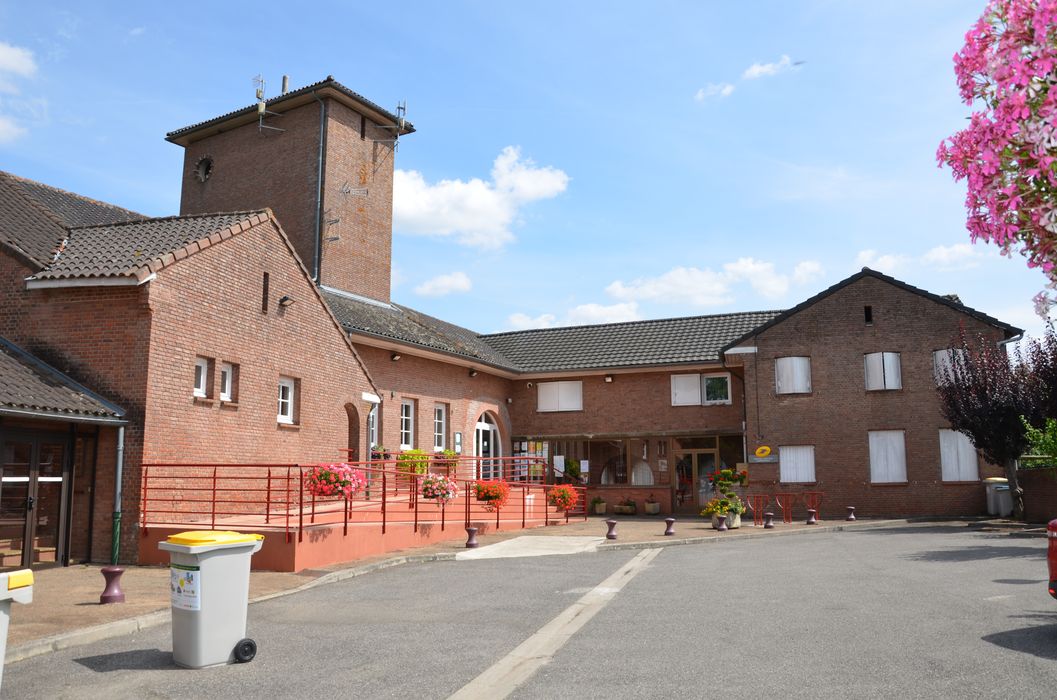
[180,102,320,279]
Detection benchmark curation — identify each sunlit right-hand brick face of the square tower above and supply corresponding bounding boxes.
[319,100,395,301]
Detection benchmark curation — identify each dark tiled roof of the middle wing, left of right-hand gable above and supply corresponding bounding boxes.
[480,311,780,372]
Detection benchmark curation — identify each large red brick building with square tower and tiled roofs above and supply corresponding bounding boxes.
[0,77,1019,564]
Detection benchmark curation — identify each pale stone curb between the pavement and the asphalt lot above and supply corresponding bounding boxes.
[4,520,951,663]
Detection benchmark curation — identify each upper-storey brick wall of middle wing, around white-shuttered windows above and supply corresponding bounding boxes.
[511,369,743,438]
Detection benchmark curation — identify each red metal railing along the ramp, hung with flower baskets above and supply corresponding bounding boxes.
[140,458,587,541]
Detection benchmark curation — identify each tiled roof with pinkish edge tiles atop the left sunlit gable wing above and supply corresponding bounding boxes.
[31,211,270,280]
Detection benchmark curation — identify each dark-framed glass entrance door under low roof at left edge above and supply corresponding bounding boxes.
[0,438,69,568]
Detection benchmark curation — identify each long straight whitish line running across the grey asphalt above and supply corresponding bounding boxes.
[449,549,661,700]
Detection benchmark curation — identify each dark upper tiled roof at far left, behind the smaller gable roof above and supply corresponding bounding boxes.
[0,171,144,266]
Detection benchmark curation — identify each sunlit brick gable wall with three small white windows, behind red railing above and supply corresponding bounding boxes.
[138,222,373,463]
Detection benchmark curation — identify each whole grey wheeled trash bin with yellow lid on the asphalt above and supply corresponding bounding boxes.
[157,530,264,668]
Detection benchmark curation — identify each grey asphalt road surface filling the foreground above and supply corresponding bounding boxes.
[2,526,1057,699]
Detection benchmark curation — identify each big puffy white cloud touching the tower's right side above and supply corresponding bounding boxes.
[393,146,569,248]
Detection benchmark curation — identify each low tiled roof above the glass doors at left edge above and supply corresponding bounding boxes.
[0,338,125,422]
